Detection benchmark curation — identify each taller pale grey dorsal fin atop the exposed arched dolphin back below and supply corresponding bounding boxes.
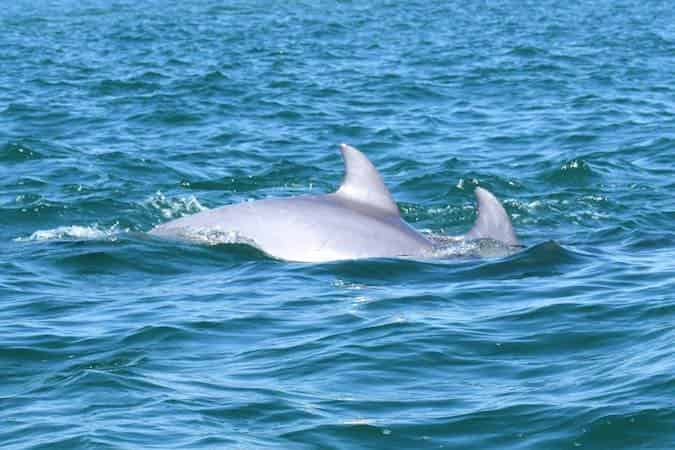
[335,144,399,216]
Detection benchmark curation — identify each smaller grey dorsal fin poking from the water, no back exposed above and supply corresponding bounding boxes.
[465,187,520,245]
